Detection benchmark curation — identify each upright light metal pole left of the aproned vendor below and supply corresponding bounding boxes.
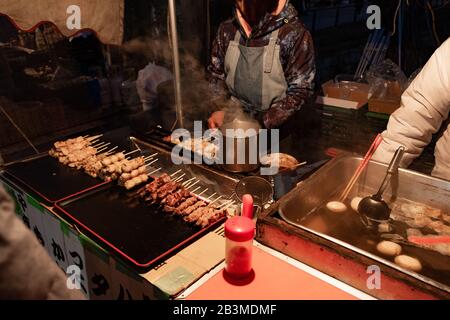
[168,0,184,128]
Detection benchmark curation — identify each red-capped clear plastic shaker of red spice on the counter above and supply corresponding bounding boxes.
[225,216,255,279]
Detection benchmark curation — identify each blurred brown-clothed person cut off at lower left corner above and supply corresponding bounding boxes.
[0,185,85,300]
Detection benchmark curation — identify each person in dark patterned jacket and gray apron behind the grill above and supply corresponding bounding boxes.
[208,0,316,129]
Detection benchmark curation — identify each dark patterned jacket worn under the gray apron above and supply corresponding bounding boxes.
[208,3,316,128]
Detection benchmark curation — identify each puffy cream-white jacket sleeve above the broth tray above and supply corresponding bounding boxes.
[373,38,450,167]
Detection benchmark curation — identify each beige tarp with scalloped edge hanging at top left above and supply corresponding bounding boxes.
[0,0,124,45]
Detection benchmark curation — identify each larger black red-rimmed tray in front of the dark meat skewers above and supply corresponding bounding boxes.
[56,185,225,270]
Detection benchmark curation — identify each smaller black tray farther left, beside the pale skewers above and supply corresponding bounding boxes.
[5,154,105,204]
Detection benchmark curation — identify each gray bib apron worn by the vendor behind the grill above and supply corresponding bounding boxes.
[225,29,288,117]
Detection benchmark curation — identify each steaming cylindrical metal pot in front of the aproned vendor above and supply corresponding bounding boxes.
[220,119,261,172]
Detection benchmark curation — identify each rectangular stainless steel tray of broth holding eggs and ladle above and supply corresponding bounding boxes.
[277,155,450,293]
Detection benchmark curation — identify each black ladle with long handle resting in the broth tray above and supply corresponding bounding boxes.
[358,146,405,221]
